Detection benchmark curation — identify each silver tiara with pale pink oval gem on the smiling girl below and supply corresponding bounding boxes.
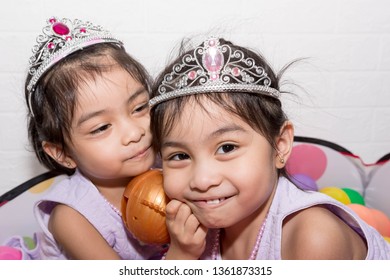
[149,37,280,107]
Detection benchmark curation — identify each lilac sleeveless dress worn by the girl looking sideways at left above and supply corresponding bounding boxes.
[6,171,163,260]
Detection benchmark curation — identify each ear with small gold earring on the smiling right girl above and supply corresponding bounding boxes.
[275,121,294,169]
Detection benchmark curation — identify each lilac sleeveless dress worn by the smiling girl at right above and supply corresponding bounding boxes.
[201,177,390,260]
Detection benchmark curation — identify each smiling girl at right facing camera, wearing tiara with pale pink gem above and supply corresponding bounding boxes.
[150,37,390,259]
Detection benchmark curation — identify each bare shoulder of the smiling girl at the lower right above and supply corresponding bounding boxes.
[282,206,367,260]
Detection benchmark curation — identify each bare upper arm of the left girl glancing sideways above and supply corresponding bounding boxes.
[49,204,120,260]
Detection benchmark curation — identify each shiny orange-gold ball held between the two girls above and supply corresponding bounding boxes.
[121,169,169,244]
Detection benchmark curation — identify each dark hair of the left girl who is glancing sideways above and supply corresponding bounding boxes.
[25,43,151,174]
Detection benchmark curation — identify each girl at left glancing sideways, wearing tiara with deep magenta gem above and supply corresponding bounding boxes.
[1,17,161,259]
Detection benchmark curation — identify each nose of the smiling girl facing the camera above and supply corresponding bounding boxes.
[190,160,222,192]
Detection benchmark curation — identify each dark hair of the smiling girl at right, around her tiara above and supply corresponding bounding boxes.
[151,39,287,176]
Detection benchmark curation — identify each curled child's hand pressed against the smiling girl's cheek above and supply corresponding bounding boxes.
[166,199,207,260]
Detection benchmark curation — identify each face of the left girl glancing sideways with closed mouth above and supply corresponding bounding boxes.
[69,67,155,185]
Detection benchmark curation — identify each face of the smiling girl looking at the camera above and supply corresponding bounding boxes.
[161,99,278,228]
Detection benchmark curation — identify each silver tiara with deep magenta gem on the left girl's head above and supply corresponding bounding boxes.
[27,17,123,113]
